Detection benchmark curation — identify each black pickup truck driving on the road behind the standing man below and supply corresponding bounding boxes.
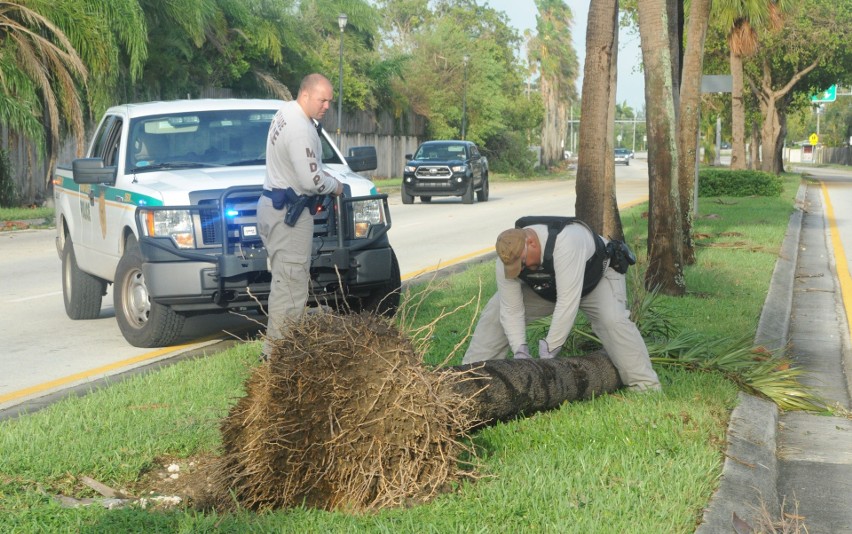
[402,141,488,204]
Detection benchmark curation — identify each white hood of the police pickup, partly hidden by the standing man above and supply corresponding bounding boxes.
[136,165,376,205]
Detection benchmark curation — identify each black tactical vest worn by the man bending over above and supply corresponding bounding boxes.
[515,215,609,302]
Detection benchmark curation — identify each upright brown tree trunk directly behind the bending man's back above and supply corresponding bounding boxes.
[574,0,621,237]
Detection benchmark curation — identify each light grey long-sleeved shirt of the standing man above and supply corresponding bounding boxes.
[263,100,337,195]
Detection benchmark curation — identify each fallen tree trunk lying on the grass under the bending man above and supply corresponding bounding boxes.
[450,351,622,425]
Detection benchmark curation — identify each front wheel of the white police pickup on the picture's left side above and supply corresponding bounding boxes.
[113,237,186,348]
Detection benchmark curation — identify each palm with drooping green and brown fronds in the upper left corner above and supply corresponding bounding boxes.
[0,0,147,197]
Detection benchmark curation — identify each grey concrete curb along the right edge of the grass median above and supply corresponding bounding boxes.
[696,184,808,534]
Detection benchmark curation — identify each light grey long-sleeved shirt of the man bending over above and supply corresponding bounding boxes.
[495,224,595,352]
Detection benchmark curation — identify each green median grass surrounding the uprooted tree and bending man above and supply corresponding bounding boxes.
[0,175,798,533]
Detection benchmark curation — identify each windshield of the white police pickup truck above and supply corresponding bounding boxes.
[126,110,275,172]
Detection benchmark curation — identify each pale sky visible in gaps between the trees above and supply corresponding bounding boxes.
[482,0,645,112]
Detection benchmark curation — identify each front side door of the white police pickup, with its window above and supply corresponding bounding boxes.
[77,115,123,280]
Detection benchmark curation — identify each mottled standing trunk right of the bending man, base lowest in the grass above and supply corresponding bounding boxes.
[639,0,686,295]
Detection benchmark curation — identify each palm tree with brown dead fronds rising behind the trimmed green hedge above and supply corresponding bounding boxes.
[712,0,793,169]
